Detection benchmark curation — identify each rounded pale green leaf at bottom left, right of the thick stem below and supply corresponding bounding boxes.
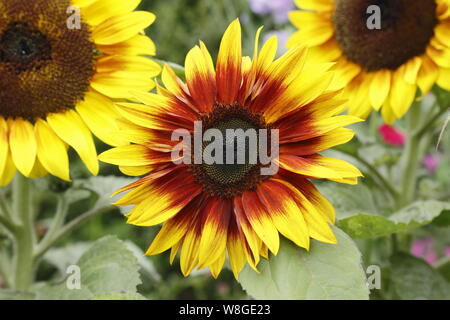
[33,236,141,300]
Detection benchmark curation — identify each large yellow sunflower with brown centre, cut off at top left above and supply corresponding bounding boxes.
[0,0,160,185]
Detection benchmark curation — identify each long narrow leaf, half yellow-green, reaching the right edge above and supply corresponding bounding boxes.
[338,200,450,239]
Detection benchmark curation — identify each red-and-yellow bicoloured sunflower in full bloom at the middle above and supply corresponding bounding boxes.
[100,20,361,277]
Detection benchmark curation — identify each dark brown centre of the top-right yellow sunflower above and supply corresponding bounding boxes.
[333,0,438,71]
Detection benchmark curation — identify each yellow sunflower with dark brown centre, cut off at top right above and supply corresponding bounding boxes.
[288,0,450,124]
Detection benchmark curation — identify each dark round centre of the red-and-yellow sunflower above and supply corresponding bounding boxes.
[190,105,270,198]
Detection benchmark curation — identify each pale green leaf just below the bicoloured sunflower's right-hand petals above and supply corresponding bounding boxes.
[317,183,378,220]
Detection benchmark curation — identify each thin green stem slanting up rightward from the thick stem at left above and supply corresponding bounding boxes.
[34,206,114,259]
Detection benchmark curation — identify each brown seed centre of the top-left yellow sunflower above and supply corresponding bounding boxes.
[0,0,95,121]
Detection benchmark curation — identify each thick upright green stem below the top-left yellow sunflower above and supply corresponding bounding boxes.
[13,173,34,291]
